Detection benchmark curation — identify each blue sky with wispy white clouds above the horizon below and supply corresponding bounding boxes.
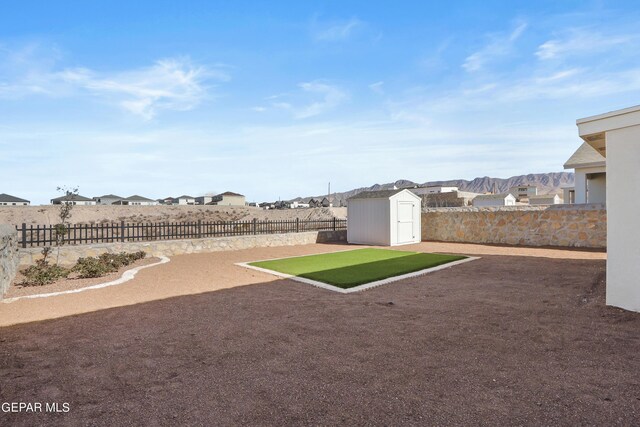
[0,0,640,203]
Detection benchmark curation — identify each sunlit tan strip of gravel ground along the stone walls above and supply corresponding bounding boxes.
[0,242,606,327]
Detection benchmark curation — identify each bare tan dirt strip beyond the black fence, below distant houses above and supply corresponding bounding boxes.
[0,205,347,226]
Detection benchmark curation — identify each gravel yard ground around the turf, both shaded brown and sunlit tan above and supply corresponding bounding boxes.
[0,244,640,426]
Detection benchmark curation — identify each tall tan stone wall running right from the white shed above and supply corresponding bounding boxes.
[422,205,607,248]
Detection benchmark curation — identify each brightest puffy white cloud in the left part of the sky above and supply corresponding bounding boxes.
[58,58,229,119]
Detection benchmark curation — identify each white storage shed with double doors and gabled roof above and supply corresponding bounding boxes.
[347,189,422,246]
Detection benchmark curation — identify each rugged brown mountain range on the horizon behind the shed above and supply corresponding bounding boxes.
[292,172,574,206]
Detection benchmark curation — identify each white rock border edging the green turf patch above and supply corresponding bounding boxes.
[235,251,480,294]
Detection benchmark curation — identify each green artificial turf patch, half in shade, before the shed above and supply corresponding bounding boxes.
[249,249,466,289]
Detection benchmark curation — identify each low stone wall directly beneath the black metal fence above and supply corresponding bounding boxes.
[20,230,347,266]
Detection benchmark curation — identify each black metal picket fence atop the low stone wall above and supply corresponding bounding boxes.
[16,218,347,248]
